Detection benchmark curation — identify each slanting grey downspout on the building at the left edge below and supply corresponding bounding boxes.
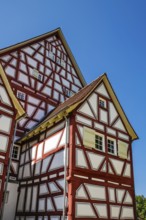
[0,116,25,220]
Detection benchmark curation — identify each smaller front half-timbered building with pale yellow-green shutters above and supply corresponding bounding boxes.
[13,74,137,220]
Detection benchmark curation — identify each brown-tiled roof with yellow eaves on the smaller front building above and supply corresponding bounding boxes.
[18,74,138,142]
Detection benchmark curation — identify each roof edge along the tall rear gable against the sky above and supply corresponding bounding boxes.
[0,28,86,86]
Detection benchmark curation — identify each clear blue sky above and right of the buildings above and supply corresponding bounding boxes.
[0,0,146,196]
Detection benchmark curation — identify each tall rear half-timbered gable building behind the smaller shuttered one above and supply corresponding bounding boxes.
[0,29,85,137]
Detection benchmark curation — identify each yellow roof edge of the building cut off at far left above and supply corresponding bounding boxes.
[0,64,26,120]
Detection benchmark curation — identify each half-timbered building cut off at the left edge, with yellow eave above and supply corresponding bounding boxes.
[0,65,25,218]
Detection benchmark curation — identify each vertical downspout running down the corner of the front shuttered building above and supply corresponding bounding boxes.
[62,117,69,220]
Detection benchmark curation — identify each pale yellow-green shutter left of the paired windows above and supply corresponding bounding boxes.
[83,127,95,148]
